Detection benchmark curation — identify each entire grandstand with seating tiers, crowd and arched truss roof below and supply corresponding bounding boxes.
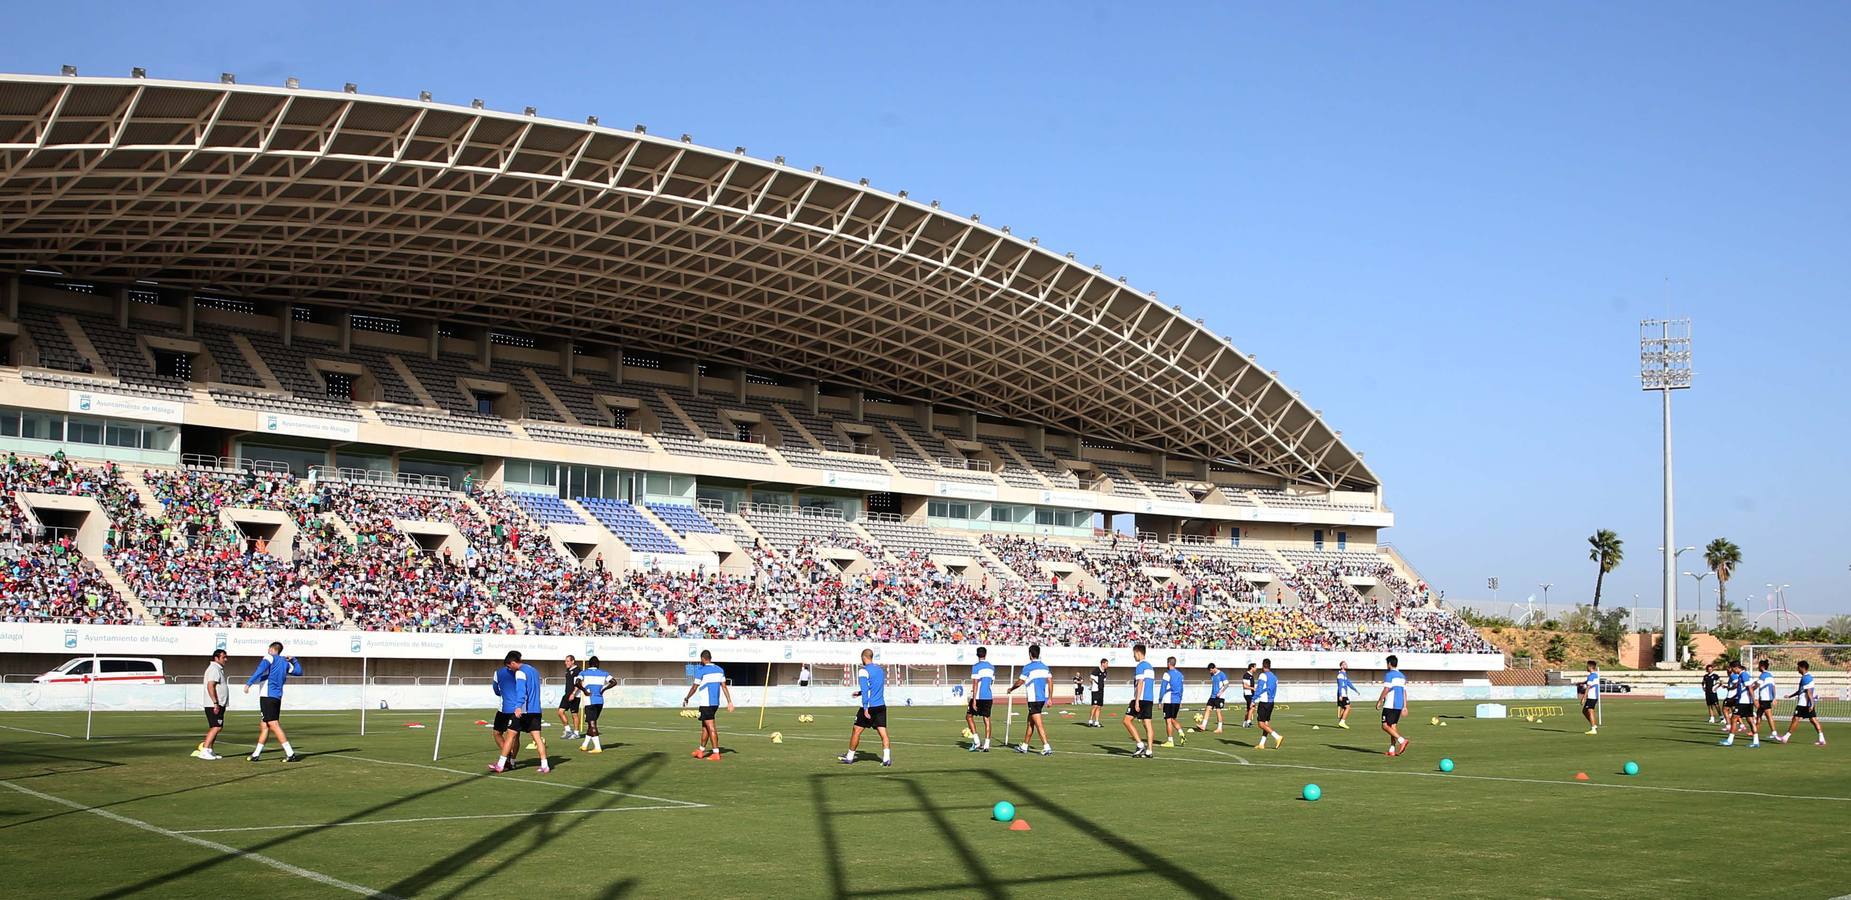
[0,76,1503,680]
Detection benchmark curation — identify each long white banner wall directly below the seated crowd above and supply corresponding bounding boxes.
[0,622,1503,672]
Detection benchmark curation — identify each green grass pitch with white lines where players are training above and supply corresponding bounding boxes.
[0,700,1851,900]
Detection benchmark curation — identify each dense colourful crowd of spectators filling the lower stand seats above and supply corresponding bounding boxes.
[0,457,1485,650]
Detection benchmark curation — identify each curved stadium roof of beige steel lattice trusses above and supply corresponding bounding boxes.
[0,76,1377,489]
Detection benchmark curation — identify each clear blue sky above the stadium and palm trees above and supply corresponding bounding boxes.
[0,2,1851,613]
